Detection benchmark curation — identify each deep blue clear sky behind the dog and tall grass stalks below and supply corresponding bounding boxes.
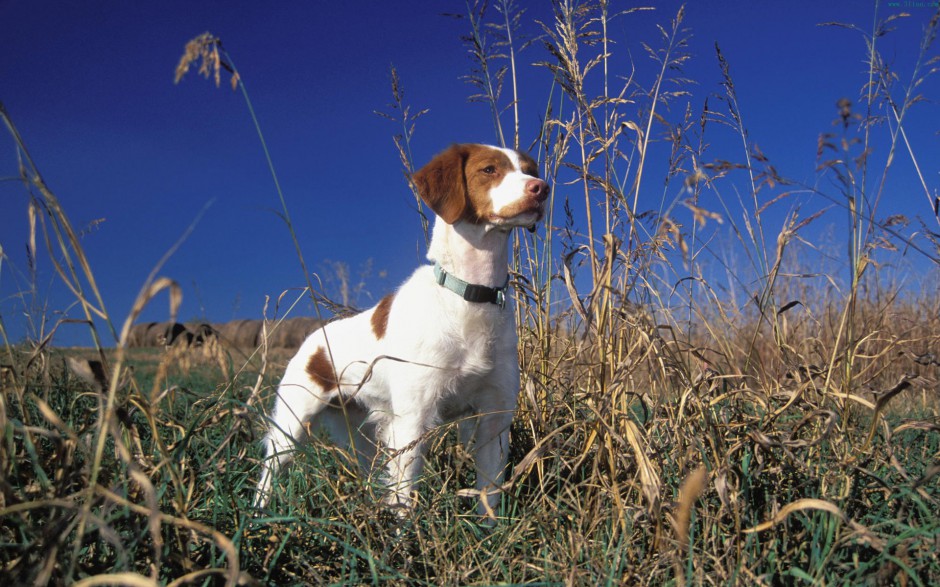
[0,0,940,344]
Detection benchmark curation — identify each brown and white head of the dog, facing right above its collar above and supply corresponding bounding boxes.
[414,144,548,229]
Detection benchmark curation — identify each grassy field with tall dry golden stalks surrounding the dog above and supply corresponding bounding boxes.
[0,2,940,586]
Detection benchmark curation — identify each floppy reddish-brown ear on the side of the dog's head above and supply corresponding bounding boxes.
[413,145,468,224]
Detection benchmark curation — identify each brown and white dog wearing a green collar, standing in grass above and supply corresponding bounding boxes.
[256,144,548,521]
